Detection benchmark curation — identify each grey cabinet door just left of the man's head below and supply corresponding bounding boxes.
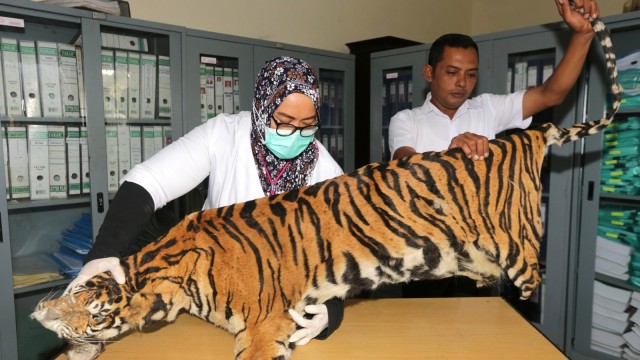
[368,45,429,162]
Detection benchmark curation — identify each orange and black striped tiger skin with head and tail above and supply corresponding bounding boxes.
[32,14,621,359]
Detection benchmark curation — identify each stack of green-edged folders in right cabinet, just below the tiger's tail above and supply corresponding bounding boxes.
[600,116,640,195]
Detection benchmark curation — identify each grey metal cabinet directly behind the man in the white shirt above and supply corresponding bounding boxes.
[370,18,582,349]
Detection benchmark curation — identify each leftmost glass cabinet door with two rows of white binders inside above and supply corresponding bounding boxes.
[0,5,91,359]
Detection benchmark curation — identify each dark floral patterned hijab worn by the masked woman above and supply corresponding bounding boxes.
[251,56,320,195]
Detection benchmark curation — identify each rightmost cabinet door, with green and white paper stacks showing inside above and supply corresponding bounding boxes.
[571,13,640,359]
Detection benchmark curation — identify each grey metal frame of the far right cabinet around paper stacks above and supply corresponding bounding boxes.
[568,12,640,359]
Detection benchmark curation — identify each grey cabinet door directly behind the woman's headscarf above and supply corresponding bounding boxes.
[254,46,355,171]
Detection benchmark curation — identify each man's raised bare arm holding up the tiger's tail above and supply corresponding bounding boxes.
[522,0,598,120]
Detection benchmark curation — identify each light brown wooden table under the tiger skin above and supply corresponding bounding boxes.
[58,297,566,360]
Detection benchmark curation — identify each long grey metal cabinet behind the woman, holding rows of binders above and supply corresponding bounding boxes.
[0,0,355,360]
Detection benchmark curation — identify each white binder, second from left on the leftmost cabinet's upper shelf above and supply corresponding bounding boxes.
[20,40,42,117]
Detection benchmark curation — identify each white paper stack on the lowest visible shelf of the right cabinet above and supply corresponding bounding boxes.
[591,281,633,357]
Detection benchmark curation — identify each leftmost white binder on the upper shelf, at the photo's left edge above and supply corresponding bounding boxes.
[0,37,23,116]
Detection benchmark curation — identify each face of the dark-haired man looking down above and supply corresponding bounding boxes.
[423,46,478,118]
